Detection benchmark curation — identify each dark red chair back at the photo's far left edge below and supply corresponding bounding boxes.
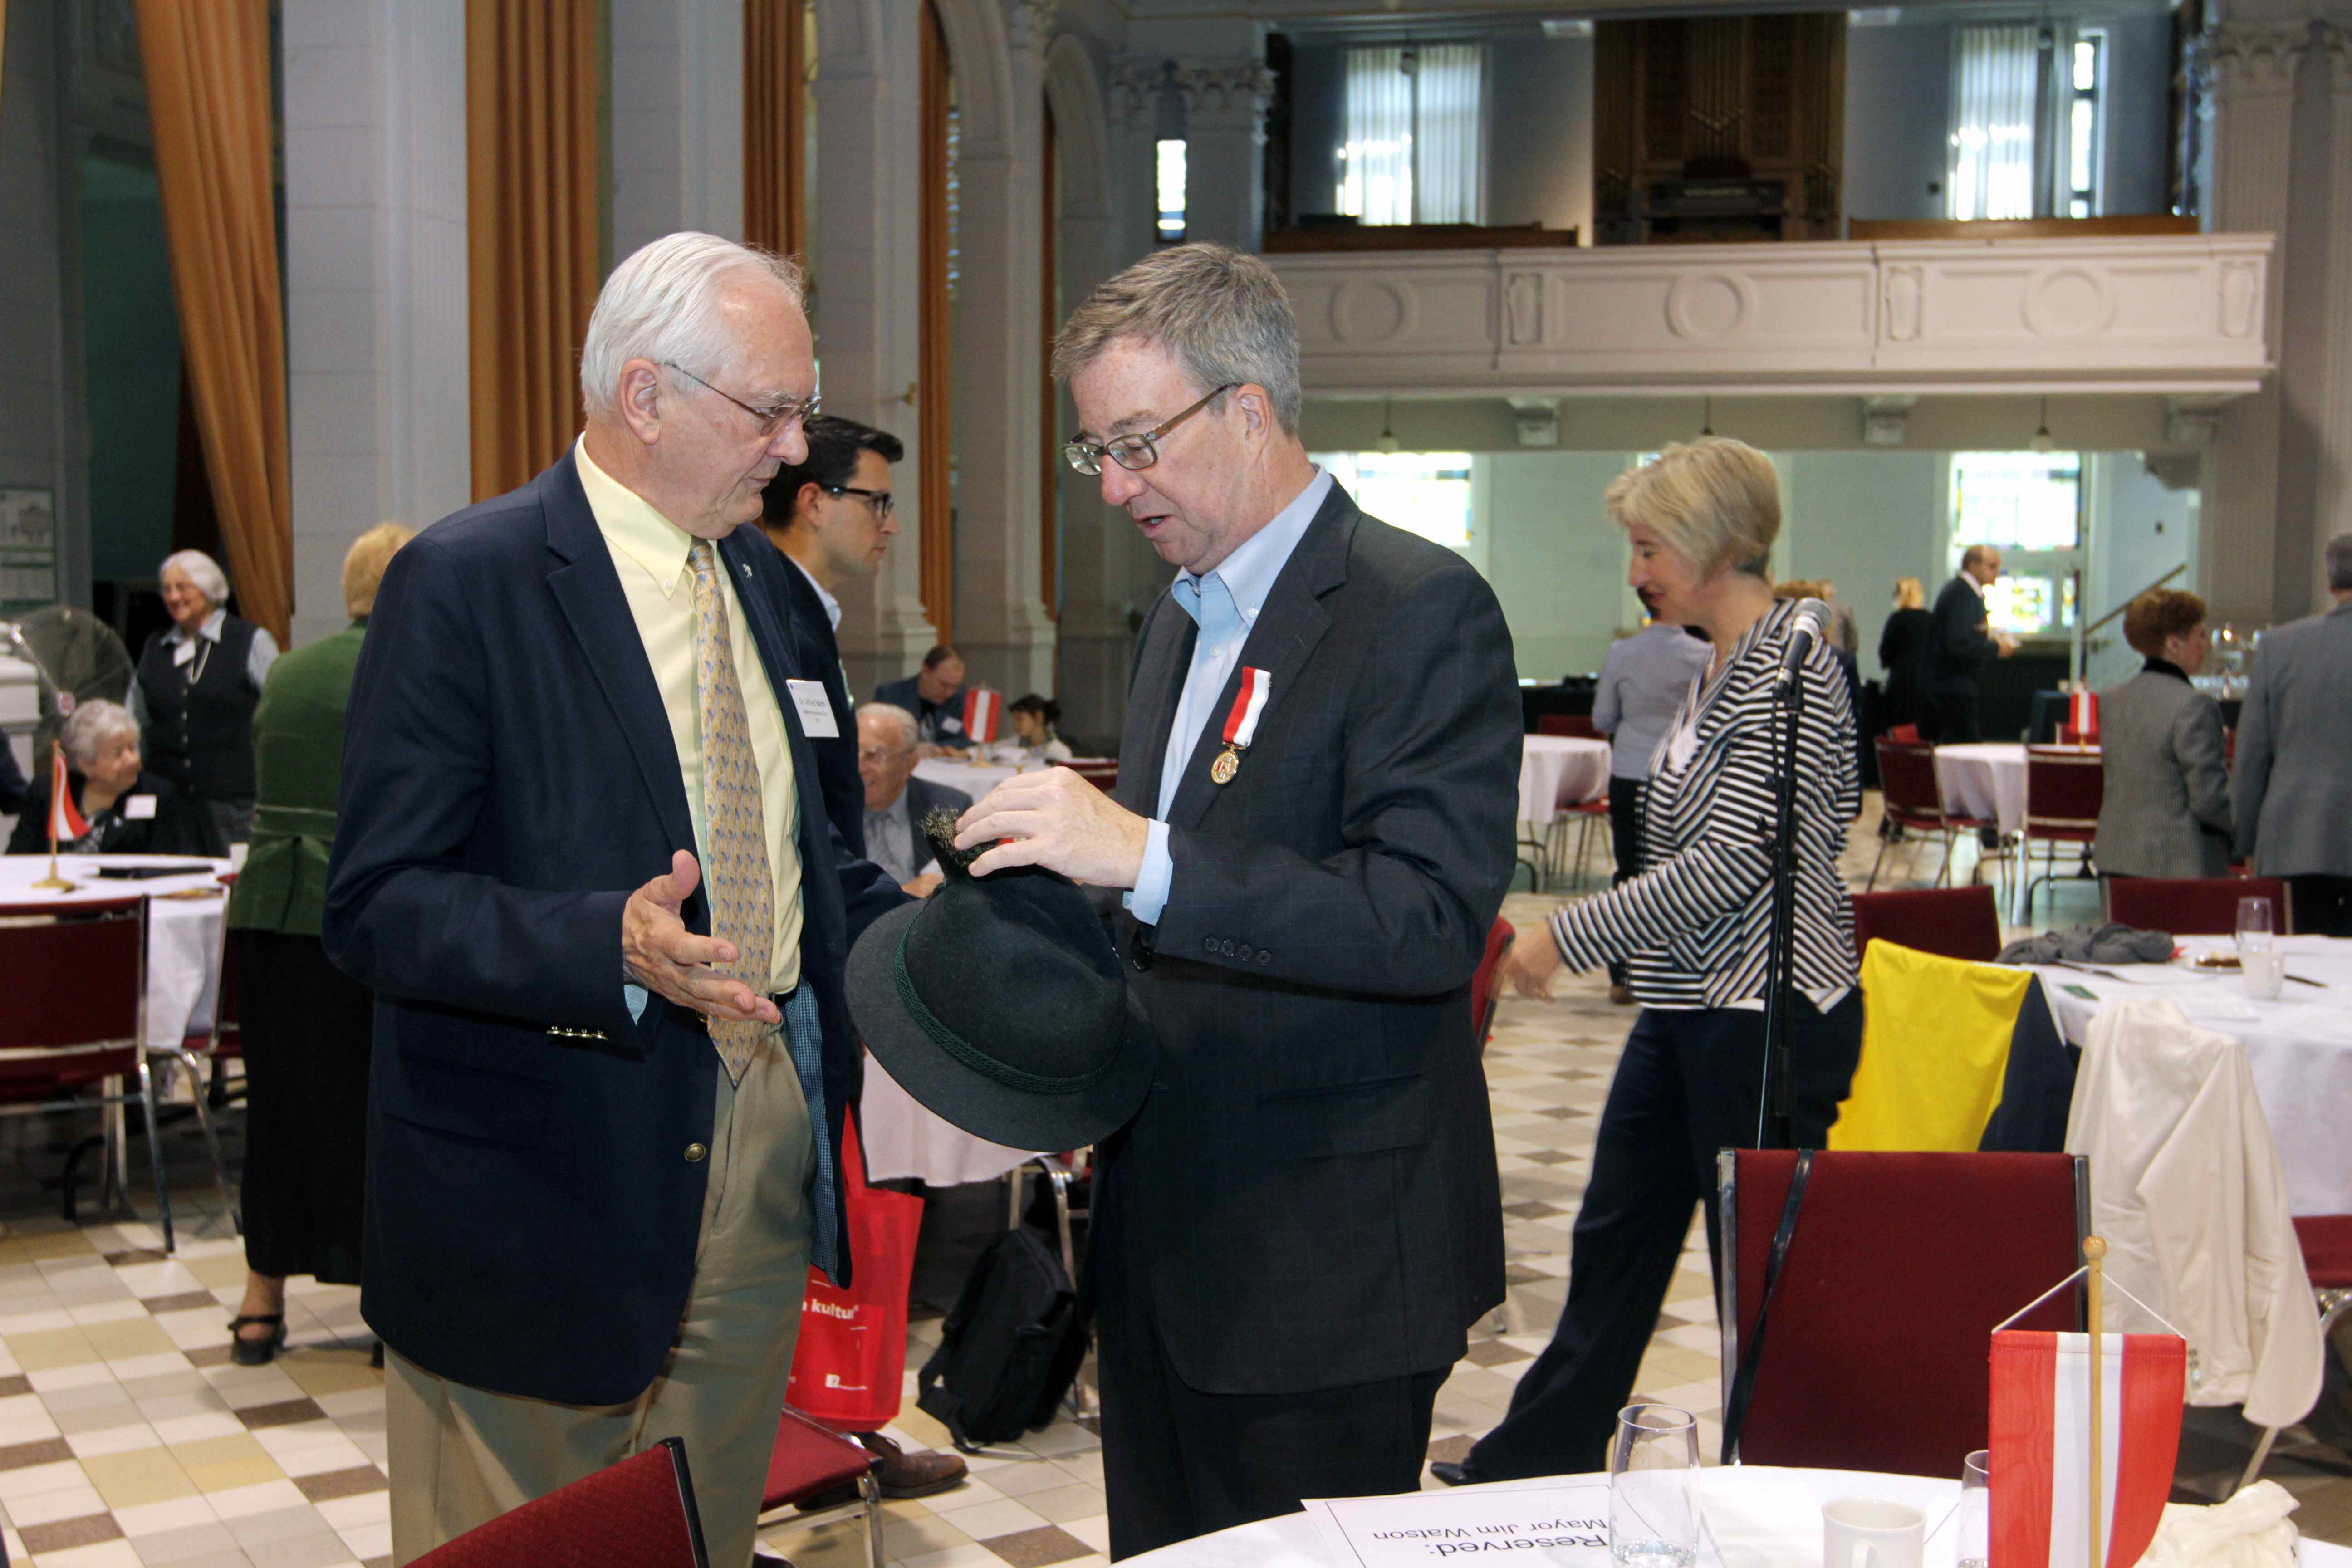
[0,898,146,1100]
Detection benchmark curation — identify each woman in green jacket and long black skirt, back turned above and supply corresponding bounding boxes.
[228,522,416,1366]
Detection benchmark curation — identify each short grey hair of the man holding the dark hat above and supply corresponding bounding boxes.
[1054,245,1305,435]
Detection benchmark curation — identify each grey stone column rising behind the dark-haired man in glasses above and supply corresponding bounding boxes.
[809,0,938,698]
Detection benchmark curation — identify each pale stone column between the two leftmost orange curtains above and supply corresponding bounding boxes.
[282,0,473,644]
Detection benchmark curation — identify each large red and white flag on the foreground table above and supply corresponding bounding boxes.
[1990,1331,2187,1568]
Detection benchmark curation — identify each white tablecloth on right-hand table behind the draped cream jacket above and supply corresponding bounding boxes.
[2037,936,2352,1215]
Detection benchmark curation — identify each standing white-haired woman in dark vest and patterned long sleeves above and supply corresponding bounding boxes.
[132,550,278,856]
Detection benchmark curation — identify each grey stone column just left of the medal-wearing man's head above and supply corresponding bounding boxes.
[950,0,1056,696]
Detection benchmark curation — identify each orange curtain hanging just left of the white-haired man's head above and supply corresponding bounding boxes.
[466,0,604,501]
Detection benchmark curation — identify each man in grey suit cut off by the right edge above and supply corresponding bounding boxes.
[2237,529,2352,936]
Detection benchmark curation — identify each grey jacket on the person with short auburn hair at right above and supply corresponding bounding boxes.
[2091,668,2230,877]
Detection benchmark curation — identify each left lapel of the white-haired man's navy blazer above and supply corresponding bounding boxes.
[536,451,694,865]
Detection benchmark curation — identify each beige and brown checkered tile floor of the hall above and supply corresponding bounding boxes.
[0,818,2352,1568]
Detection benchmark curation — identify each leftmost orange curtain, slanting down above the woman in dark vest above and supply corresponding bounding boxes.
[139,0,294,647]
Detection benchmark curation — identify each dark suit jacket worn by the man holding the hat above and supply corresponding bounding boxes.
[1098,487,1519,1394]
